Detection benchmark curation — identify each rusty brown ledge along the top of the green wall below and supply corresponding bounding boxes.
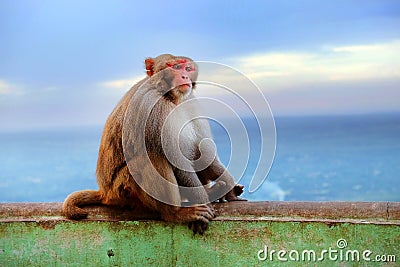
[0,201,400,225]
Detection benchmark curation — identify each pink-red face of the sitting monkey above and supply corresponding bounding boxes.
[167,59,197,94]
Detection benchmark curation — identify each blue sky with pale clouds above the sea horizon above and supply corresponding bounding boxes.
[0,0,400,129]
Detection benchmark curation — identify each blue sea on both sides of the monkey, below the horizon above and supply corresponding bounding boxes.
[0,113,400,202]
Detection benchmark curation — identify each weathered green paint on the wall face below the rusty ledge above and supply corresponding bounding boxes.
[0,203,400,266]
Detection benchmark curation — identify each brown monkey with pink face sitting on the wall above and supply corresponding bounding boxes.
[62,54,245,235]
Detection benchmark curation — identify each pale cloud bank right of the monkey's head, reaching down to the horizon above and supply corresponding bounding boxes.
[192,40,400,114]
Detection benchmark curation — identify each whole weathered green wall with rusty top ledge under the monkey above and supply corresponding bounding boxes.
[0,201,400,267]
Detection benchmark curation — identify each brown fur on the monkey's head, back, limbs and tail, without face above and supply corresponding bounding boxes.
[62,54,243,234]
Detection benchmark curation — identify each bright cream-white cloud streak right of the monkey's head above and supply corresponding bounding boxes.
[228,40,400,89]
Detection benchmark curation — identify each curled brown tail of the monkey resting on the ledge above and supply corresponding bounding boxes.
[62,190,103,220]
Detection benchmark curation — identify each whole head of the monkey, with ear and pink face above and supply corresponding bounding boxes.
[145,54,198,102]
